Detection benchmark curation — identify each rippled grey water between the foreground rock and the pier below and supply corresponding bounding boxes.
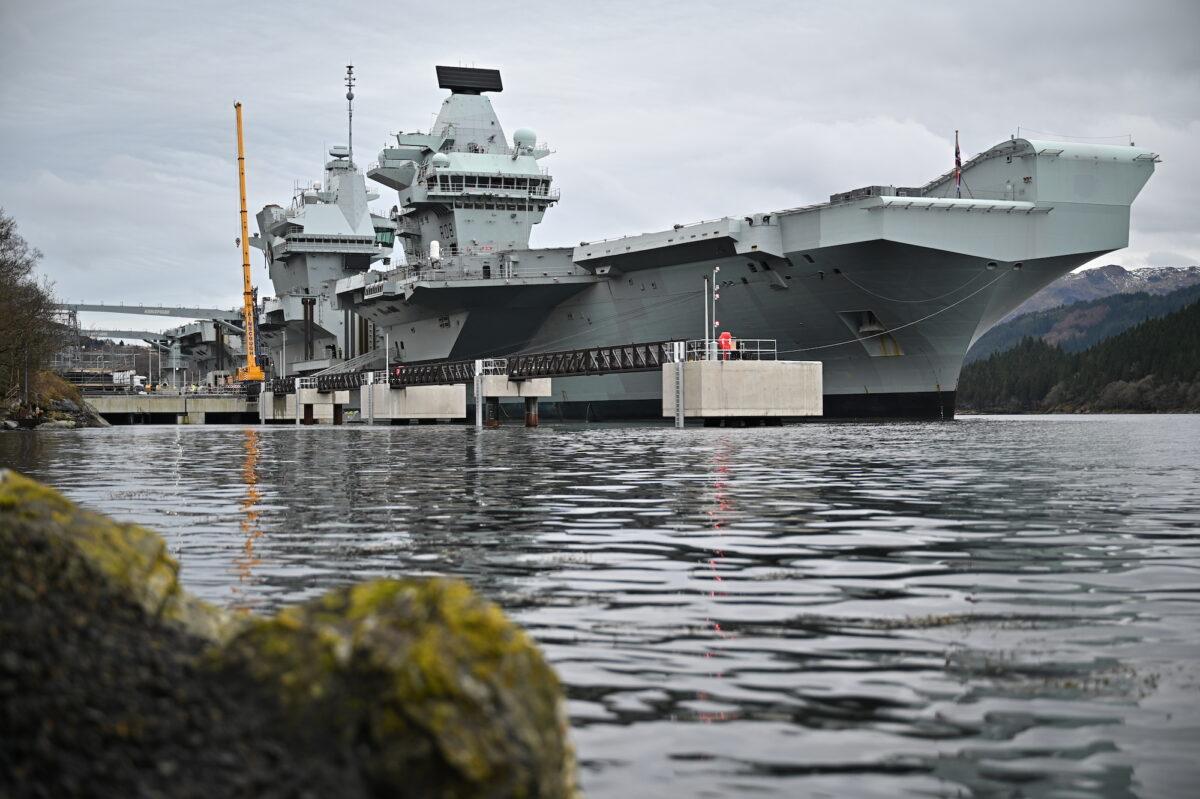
[0,416,1200,798]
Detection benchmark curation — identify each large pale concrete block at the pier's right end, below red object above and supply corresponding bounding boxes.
[662,360,823,422]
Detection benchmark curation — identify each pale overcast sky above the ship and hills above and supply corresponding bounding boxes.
[0,0,1200,329]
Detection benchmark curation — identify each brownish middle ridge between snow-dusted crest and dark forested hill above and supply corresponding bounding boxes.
[965,283,1200,364]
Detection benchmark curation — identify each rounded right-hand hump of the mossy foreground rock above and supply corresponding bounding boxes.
[216,579,574,797]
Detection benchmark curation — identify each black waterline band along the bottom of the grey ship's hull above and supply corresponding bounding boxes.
[538,391,954,421]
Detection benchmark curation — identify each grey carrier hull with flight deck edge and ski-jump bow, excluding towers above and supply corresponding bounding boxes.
[343,130,1156,419]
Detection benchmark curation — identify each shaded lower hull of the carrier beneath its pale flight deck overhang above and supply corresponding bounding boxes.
[343,240,1099,420]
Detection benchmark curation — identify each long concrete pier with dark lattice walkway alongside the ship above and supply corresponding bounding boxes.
[82,338,823,427]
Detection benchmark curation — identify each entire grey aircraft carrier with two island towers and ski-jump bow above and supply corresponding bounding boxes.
[254,66,1158,419]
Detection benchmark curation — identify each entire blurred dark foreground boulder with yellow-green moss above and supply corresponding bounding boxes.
[0,470,576,798]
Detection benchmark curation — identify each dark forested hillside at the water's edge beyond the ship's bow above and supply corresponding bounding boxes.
[958,297,1200,413]
